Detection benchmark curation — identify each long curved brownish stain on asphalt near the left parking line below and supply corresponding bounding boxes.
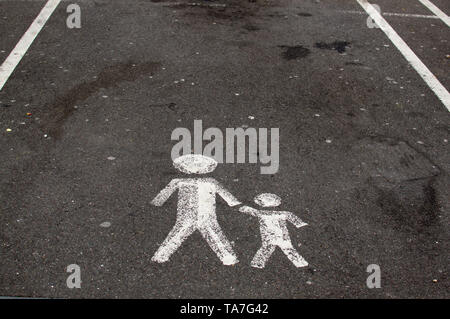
[42,62,159,138]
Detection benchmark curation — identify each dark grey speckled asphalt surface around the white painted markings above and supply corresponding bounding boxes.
[0,0,450,298]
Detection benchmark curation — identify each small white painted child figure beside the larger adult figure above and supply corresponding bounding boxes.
[239,193,308,268]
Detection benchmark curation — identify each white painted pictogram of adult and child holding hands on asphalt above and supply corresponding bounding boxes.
[152,154,308,268]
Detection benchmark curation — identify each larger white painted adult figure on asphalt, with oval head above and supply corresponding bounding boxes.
[152,154,241,265]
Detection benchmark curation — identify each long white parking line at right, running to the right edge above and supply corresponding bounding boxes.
[356,0,450,111]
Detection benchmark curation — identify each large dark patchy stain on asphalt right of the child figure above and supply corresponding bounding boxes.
[352,135,443,236]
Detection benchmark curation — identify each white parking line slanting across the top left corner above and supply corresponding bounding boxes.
[0,0,61,91]
